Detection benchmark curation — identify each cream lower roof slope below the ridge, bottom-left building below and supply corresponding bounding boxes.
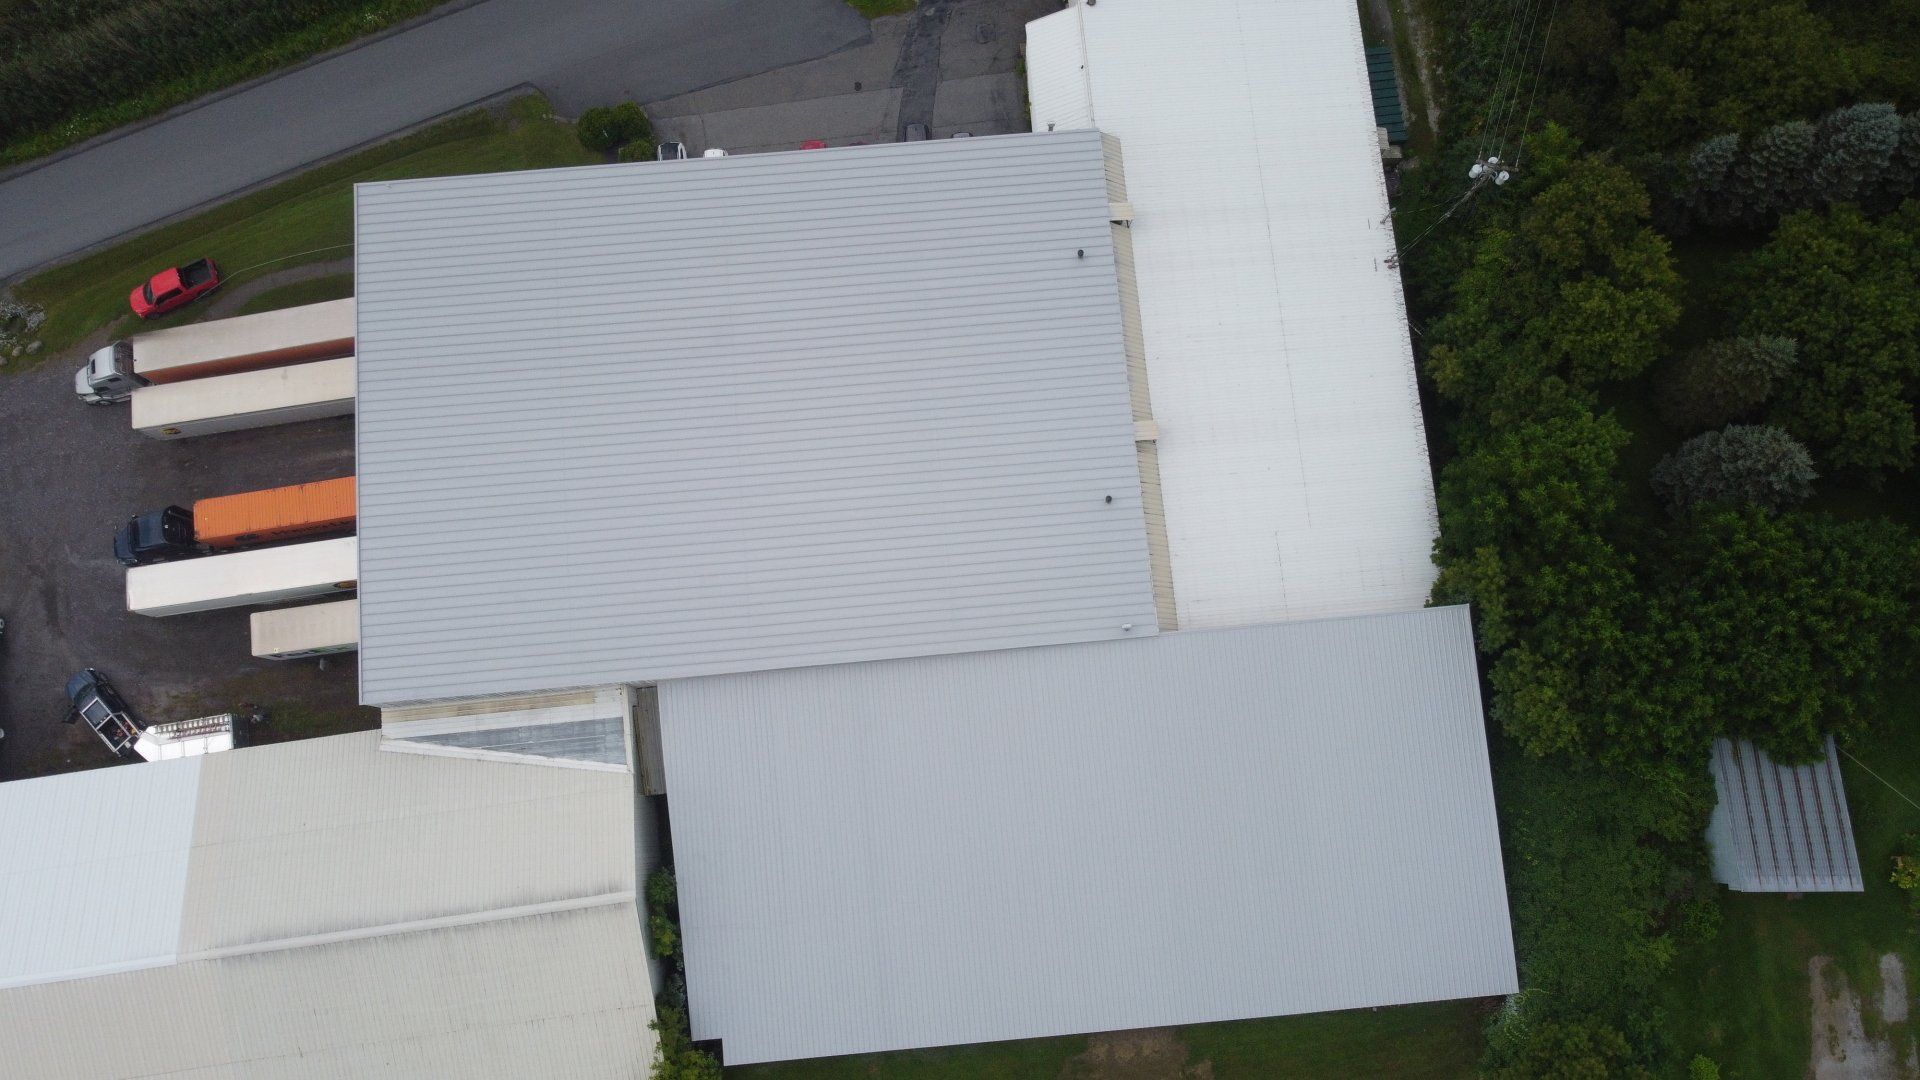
[0,899,655,1080]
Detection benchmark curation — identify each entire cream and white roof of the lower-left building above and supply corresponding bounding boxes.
[0,732,653,1080]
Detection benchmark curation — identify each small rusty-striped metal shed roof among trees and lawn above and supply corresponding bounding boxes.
[1707,736,1864,892]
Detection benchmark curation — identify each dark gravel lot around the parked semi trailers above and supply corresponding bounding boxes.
[0,328,357,778]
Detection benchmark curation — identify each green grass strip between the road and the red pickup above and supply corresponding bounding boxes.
[13,94,599,357]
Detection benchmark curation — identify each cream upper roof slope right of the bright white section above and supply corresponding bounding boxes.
[180,732,634,953]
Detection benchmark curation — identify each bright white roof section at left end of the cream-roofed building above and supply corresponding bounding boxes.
[0,757,202,983]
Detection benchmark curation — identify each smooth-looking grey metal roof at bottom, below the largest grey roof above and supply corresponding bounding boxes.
[659,607,1517,1065]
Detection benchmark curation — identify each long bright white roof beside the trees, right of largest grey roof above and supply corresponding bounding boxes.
[1027,0,1438,628]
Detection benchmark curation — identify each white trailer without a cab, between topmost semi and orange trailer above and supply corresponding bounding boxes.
[132,356,359,440]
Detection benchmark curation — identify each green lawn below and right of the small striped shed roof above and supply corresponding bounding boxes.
[1665,684,1920,1080]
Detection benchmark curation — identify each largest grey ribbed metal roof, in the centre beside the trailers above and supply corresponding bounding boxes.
[355,133,1156,705]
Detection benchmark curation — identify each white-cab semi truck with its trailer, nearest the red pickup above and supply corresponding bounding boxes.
[73,298,355,405]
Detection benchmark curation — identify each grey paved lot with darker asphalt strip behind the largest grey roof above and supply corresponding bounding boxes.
[647,0,1060,154]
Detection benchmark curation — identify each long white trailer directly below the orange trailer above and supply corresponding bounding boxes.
[127,536,359,617]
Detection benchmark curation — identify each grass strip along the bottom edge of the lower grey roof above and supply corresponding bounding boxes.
[726,1001,1482,1080]
